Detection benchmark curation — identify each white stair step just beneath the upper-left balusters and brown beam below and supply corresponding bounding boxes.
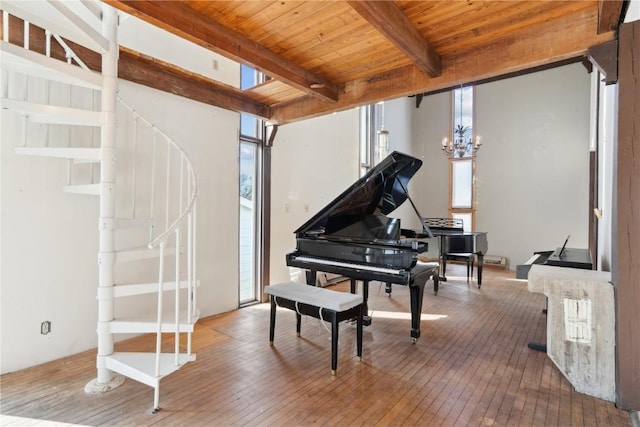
[0,40,102,90]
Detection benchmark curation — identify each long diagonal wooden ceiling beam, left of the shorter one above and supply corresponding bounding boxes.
[104,0,339,101]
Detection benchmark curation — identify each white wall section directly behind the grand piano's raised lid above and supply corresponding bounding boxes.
[270,109,360,283]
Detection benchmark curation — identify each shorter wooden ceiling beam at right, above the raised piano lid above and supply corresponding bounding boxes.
[347,1,442,77]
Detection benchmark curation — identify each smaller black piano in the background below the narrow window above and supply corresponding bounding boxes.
[425,218,488,287]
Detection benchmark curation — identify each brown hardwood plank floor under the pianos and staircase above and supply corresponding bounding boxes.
[0,265,632,426]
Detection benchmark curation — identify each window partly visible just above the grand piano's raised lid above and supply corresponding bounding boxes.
[360,102,389,176]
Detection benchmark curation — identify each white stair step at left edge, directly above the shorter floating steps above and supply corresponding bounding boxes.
[0,98,102,126]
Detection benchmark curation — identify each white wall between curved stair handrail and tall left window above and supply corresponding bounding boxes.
[120,82,240,316]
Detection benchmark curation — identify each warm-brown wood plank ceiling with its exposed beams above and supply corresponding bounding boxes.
[103,0,624,124]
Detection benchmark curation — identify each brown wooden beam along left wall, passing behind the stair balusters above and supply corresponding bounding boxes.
[2,17,270,119]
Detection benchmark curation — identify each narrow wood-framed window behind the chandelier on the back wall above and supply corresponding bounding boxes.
[449,86,476,231]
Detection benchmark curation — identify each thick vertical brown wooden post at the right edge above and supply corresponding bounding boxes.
[611,21,640,411]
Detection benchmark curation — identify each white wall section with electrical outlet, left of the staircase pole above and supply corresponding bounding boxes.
[0,91,98,373]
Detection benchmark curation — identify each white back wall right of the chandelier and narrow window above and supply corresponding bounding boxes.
[476,64,591,269]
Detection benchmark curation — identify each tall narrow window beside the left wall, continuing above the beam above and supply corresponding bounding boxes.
[238,65,264,305]
